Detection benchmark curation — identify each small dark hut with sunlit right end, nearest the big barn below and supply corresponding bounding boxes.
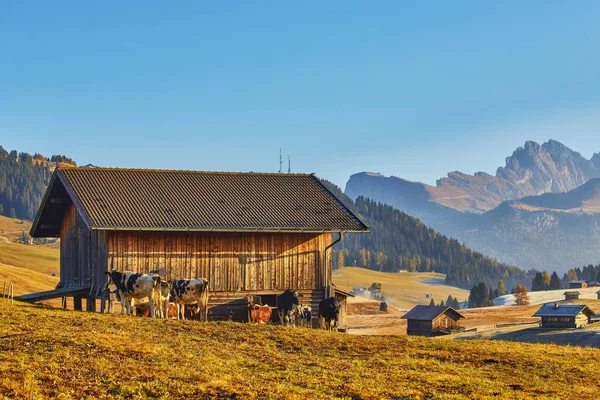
[402,306,465,336]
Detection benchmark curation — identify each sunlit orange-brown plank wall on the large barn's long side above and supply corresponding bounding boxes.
[107,231,331,292]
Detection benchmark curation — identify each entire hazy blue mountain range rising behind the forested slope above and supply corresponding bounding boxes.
[345,140,600,272]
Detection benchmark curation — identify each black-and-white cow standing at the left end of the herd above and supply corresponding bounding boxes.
[104,270,160,317]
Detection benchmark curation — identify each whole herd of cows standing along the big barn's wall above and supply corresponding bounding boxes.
[103,270,340,330]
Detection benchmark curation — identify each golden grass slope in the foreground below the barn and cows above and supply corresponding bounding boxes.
[0,303,600,399]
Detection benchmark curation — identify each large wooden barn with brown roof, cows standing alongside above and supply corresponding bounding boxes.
[31,168,368,320]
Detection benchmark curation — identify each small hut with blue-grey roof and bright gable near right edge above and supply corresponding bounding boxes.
[533,303,596,329]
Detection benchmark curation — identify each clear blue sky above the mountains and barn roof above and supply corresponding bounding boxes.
[0,0,600,187]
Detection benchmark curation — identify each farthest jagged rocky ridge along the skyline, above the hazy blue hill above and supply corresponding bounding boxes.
[345,140,600,214]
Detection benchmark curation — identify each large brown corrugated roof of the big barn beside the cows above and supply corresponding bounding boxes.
[31,168,368,237]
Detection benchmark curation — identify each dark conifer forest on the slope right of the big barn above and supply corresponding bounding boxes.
[324,181,531,289]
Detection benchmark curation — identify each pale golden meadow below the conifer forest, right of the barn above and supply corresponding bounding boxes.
[333,267,469,310]
